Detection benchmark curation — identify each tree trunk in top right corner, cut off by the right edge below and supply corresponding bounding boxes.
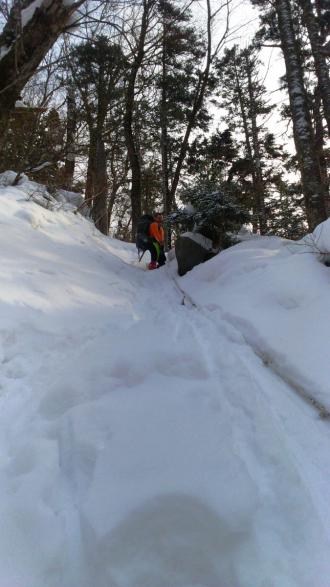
[298,0,330,136]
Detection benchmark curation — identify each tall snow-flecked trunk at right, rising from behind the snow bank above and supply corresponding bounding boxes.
[275,0,327,230]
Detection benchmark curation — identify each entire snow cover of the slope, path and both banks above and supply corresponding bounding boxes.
[0,178,330,587]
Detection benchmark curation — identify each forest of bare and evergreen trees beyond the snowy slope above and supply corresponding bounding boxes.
[0,0,330,244]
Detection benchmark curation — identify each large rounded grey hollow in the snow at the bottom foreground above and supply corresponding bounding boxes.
[86,494,245,587]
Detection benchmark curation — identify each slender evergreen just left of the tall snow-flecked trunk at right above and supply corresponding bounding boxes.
[217,45,281,234]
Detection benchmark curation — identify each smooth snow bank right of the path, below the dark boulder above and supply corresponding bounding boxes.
[180,225,330,410]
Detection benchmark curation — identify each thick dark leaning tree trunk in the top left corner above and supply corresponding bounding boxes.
[0,0,83,123]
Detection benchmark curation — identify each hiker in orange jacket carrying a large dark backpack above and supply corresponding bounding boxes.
[136,212,166,269]
